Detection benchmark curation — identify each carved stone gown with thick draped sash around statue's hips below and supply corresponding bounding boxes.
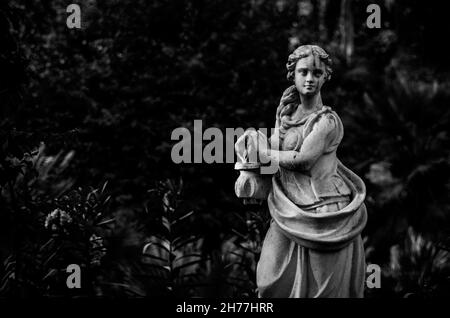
[257,107,367,298]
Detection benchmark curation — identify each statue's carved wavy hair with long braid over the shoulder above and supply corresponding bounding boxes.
[276,45,333,138]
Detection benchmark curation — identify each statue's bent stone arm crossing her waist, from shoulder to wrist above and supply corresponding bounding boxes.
[259,114,336,171]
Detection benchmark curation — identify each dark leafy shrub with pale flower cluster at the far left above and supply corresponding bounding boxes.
[0,140,114,296]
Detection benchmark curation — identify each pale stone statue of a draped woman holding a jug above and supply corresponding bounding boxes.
[235,45,367,298]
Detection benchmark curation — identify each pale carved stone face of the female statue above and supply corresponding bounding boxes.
[294,54,327,96]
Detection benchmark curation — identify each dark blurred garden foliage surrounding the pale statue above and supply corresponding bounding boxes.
[0,0,450,298]
